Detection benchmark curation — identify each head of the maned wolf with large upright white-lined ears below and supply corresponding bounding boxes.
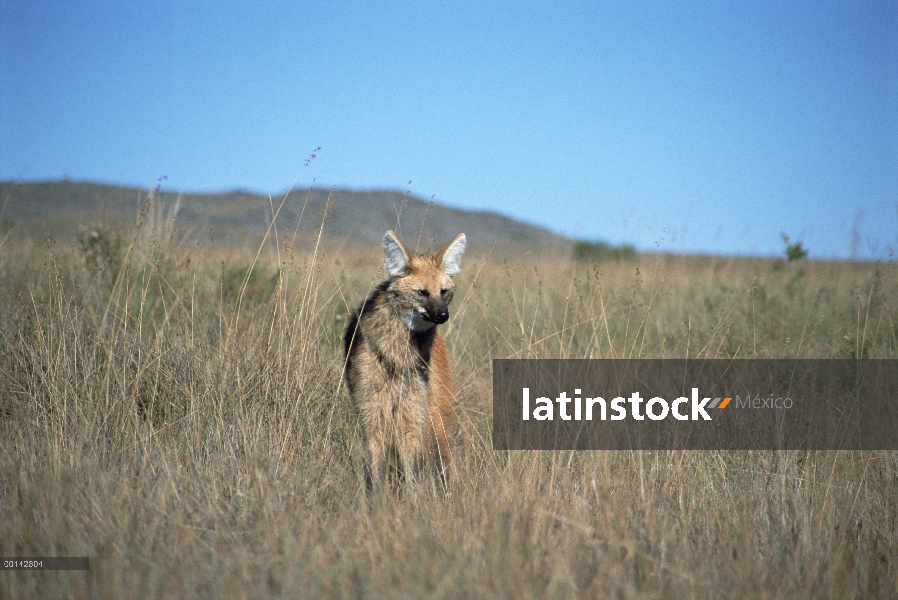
[383,231,467,331]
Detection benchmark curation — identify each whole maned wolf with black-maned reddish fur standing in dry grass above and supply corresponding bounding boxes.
[343,231,467,486]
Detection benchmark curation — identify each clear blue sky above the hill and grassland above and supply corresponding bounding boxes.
[0,0,898,259]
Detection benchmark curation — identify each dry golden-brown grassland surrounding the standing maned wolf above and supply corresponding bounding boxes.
[0,195,898,598]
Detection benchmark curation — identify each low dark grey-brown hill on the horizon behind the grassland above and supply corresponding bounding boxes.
[0,180,571,252]
